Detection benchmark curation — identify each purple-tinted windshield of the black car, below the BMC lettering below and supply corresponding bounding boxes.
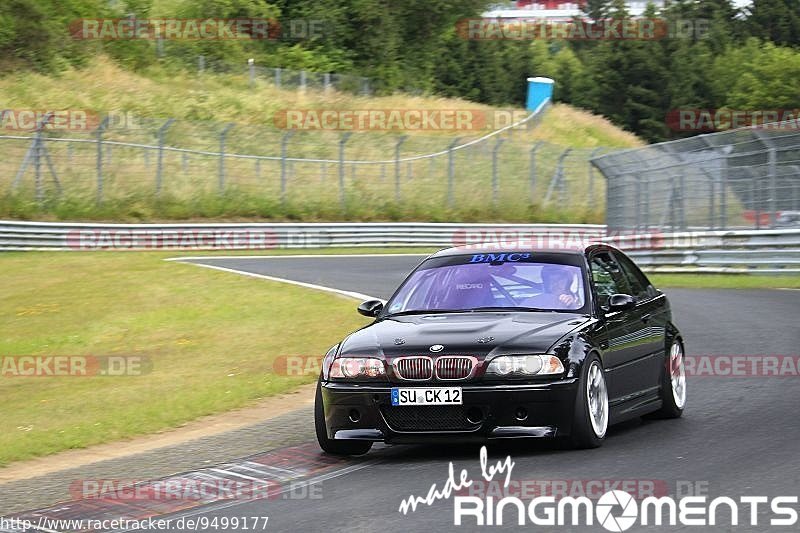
[387,253,586,315]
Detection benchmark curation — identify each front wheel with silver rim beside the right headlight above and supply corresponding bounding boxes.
[570,354,609,448]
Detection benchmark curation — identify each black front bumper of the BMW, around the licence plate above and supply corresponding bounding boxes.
[322,379,577,443]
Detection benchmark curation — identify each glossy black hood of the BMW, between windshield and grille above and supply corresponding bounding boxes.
[340,312,590,358]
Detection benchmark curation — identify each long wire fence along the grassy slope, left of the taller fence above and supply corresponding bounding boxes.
[0,110,605,221]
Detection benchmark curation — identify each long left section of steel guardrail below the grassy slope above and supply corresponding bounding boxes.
[0,221,605,251]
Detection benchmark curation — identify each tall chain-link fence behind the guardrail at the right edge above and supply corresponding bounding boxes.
[593,121,800,231]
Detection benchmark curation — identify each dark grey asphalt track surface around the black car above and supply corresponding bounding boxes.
[12,256,800,533]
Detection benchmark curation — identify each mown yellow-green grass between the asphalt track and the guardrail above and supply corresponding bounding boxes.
[0,249,800,465]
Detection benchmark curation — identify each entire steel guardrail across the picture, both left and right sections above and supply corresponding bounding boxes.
[0,221,800,273]
